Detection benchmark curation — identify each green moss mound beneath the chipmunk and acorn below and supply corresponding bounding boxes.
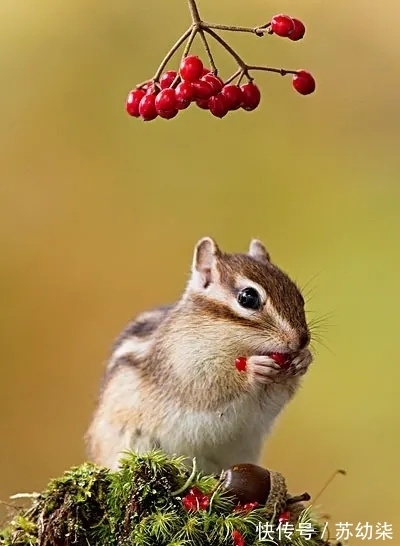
[0,452,334,546]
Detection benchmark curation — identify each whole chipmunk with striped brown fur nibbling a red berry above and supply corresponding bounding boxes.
[85,237,313,474]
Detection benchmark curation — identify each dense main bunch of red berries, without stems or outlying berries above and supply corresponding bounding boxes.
[126,55,261,121]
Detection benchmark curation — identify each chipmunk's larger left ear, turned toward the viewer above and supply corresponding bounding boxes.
[192,237,221,288]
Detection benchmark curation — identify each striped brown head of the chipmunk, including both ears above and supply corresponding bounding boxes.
[185,237,310,354]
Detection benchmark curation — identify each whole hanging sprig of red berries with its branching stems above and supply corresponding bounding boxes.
[125,7,316,121]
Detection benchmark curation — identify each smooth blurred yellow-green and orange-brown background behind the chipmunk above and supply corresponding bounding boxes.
[0,0,400,540]
